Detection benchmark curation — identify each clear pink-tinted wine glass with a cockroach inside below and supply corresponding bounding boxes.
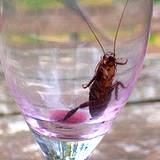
[0,0,153,160]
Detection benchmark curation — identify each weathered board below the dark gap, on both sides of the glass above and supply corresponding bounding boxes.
[0,103,160,160]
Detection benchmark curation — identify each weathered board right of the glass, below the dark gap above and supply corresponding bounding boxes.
[93,103,160,160]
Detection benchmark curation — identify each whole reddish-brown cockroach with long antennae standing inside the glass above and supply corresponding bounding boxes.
[63,0,129,121]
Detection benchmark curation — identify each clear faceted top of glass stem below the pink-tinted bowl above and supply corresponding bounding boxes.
[32,130,103,160]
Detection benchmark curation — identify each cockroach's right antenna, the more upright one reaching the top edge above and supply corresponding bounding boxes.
[113,0,129,57]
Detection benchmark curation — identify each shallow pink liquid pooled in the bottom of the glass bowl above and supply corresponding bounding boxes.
[25,107,112,140]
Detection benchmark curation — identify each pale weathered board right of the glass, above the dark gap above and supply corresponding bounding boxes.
[129,54,160,102]
